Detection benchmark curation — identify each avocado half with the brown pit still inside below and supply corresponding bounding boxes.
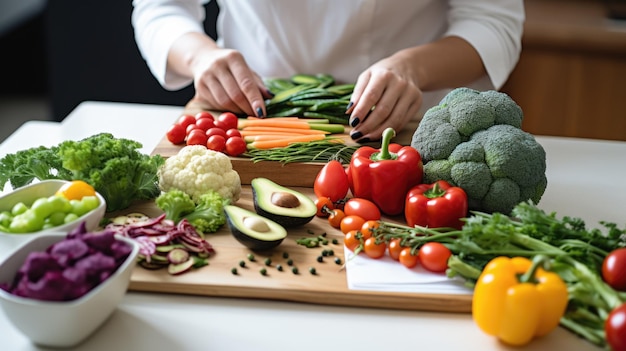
[250,178,317,227]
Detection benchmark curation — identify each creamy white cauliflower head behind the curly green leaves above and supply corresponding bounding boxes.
[157,145,241,203]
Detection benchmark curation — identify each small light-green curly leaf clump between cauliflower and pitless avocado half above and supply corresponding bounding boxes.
[184,190,229,233]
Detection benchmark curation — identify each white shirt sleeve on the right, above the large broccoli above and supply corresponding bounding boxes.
[446,0,525,89]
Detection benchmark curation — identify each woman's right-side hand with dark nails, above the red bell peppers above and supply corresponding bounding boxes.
[347,52,422,142]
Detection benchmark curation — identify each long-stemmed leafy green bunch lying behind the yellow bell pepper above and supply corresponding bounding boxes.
[374,202,626,347]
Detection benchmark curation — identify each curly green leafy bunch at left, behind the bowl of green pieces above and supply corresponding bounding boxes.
[0,133,164,212]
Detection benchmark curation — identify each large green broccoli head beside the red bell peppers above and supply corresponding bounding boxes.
[411,88,547,214]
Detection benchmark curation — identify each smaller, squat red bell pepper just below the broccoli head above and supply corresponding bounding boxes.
[404,180,468,229]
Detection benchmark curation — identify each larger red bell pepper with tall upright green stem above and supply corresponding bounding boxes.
[348,128,424,215]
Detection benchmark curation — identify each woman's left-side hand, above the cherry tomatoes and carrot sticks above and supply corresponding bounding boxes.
[191,49,271,117]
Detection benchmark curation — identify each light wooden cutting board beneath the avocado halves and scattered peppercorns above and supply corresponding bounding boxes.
[124,186,471,313]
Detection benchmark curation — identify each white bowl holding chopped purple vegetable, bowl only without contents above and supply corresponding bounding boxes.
[0,233,139,347]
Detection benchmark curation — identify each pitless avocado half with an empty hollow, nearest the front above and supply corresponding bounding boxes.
[224,205,287,251]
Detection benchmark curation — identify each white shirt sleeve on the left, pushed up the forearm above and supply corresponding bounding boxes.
[131,0,206,90]
